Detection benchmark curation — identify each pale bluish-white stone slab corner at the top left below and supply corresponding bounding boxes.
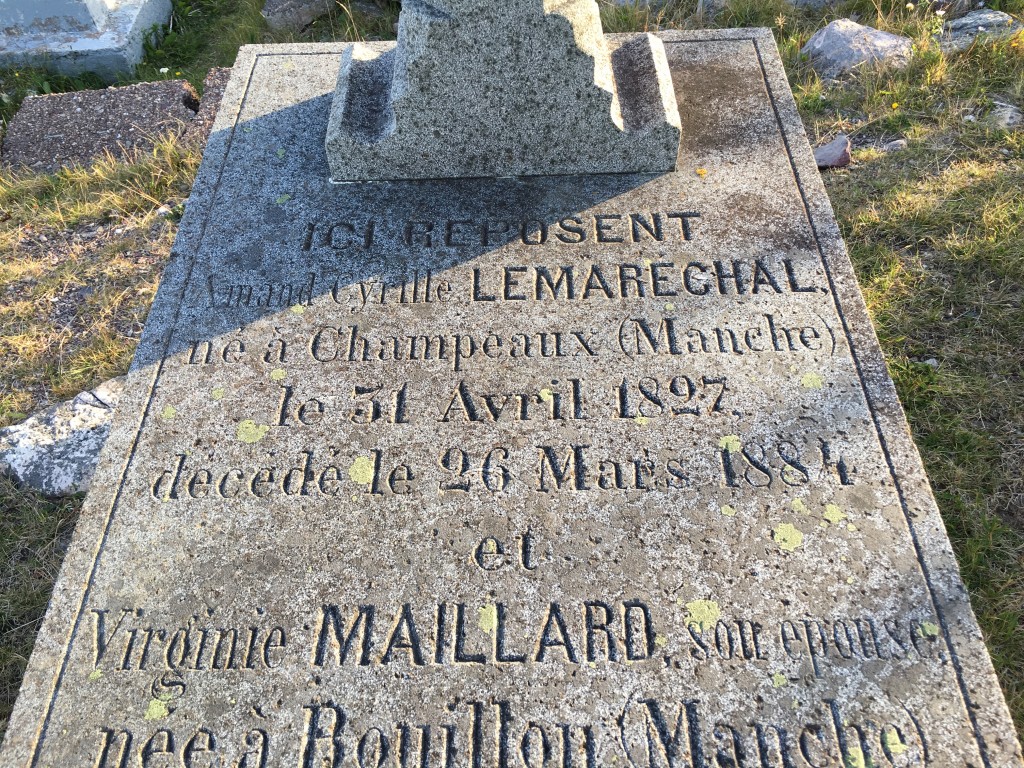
[0,0,171,82]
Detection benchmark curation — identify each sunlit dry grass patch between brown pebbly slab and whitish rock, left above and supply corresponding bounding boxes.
[0,137,199,426]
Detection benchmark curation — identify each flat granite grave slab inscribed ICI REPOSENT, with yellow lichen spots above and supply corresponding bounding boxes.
[0,30,1020,768]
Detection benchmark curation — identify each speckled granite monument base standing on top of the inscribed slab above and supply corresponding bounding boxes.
[327,0,679,181]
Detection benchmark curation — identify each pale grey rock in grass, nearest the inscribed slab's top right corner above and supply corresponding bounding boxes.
[801,18,913,79]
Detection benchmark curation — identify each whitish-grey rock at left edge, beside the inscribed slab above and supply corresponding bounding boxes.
[0,377,124,496]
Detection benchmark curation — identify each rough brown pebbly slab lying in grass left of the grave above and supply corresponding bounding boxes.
[0,80,199,171]
